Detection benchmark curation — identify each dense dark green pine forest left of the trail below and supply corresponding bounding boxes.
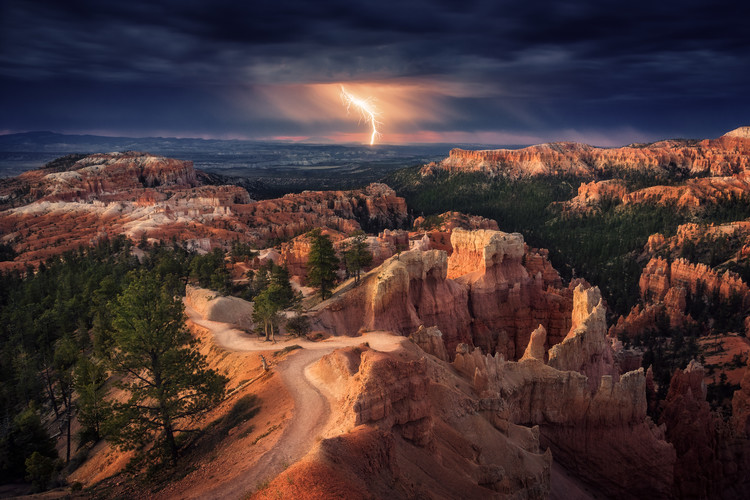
[0,236,235,488]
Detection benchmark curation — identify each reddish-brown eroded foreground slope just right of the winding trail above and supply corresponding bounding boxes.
[310,342,552,499]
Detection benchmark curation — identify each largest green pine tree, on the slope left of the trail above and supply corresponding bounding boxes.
[111,270,227,463]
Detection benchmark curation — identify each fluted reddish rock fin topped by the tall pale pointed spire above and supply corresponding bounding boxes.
[453,289,675,498]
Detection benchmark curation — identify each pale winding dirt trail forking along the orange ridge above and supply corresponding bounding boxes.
[185,304,404,499]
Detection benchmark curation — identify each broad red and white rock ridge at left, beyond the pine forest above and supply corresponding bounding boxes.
[0,153,409,268]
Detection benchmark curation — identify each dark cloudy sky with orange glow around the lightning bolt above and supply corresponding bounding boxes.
[0,0,750,145]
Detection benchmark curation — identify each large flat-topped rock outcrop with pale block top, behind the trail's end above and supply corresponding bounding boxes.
[315,228,573,359]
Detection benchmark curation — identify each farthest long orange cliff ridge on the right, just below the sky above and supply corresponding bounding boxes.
[422,129,750,178]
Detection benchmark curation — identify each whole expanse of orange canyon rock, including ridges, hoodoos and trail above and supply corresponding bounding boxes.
[0,128,750,499]
